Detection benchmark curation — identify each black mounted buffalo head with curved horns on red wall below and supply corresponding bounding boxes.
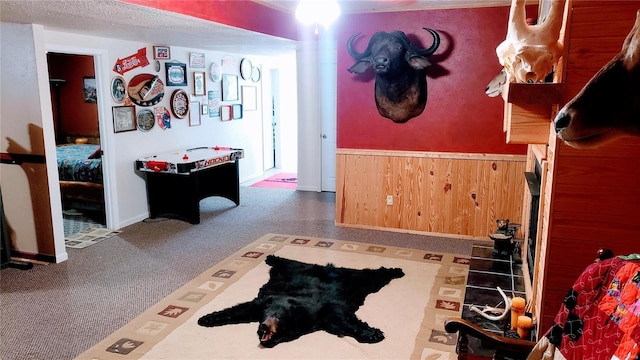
[347,28,440,123]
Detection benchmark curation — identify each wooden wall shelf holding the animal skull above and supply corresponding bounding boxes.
[502,83,565,144]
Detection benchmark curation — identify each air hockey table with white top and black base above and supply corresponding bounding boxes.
[135,146,244,224]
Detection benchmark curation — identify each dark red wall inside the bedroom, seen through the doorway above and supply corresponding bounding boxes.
[47,53,100,137]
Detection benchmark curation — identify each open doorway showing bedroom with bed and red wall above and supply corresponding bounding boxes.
[47,52,106,239]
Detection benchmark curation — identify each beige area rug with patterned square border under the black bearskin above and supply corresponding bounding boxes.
[78,234,469,360]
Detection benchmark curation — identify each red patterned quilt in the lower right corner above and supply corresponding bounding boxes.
[545,256,640,360]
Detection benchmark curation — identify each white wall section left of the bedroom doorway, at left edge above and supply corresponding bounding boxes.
[0,23,67,261]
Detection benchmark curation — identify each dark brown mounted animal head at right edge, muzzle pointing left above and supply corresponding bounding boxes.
[554,10,640,148]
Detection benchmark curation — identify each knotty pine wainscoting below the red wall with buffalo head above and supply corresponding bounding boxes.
[336,149,526,240]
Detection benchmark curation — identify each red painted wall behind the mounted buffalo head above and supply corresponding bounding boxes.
[336,7,530,154]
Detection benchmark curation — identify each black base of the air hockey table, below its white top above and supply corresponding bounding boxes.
[145,160,240,224]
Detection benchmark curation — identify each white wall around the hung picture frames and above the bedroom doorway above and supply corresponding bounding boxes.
[45,31,296,228]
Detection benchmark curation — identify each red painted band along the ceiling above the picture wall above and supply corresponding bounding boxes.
[120,0,298,40]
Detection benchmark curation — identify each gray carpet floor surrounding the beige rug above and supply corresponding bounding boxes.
[0,186,472,360]
